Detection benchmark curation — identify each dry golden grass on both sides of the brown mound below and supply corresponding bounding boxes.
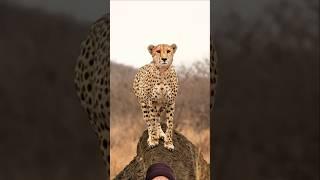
[110,117,210,178]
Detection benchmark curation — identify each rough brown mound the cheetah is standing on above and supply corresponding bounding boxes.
[115,124,210,180]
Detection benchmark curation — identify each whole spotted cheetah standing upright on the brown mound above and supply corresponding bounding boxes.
[133,44,178,151]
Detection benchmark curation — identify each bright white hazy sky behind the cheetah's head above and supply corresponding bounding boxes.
[110,0,210,67]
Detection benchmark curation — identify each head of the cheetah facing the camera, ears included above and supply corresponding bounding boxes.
[148,44,177,69]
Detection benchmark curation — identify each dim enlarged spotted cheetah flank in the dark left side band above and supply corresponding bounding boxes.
[74,14,110,177]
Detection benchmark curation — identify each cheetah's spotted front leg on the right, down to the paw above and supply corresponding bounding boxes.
[164,103,175,151]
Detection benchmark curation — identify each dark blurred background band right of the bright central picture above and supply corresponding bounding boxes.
[211,0,319,180]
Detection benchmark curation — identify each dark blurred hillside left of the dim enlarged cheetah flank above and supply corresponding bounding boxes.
[0,2,106,180]
